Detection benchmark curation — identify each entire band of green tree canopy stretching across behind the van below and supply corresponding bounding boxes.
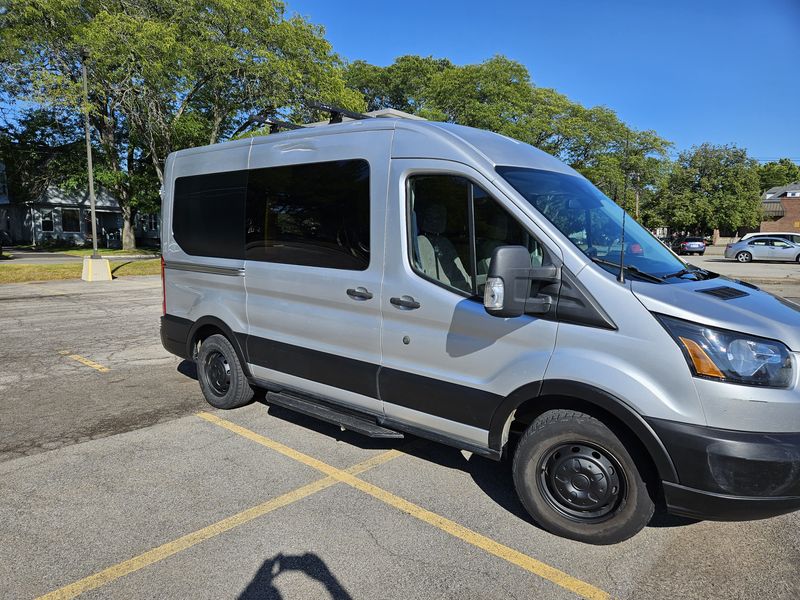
[0,7,800,248]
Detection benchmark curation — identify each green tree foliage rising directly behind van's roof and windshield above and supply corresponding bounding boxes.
[346,56,670,221]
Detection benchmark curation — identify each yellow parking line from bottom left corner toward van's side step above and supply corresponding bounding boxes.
[37,438,405,600]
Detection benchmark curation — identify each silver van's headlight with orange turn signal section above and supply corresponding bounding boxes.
[656,315,793,388]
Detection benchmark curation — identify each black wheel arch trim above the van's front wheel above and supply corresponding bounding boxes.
[489,379,678,483]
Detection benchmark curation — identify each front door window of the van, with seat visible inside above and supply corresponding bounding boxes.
[408,175,543,296]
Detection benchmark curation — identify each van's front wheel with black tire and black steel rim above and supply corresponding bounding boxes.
[512,410,655,544]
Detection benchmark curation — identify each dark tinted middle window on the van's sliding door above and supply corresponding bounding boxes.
[246,160,370,271]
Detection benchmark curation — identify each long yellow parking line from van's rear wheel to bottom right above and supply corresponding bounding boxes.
[198,412,610,600]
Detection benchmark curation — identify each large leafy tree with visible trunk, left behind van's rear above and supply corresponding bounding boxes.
[0,0,356,248]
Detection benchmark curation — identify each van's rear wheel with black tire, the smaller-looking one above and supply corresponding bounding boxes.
[197,334,253,409]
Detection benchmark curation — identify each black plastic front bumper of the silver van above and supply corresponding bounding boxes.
[647,419,800,521]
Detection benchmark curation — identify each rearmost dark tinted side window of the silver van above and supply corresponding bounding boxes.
[172,171,247,258]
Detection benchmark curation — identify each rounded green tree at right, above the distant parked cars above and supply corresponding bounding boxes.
[660,144,761,233]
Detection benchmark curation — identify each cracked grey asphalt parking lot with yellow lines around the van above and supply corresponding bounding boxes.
[0,274,800,600]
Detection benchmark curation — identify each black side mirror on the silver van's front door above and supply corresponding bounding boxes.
[483,246,560,317]
